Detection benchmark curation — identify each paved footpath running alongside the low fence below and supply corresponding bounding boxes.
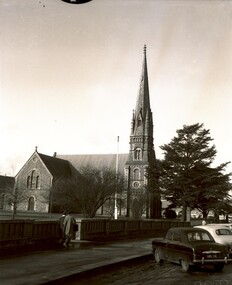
[0,238,152,285]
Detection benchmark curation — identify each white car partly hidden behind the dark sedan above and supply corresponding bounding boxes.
[194,224,232,257]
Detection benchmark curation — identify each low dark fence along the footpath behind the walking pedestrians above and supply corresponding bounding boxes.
[0,219,190,247]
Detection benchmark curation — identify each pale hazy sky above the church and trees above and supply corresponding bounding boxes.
[0,0,232,176]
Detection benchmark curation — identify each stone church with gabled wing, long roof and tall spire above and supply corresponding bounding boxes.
[12,46,161,218]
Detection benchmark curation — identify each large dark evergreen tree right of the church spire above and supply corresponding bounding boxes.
[155,123,232,218]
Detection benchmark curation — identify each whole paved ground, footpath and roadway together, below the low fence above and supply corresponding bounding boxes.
[0,239,232,285]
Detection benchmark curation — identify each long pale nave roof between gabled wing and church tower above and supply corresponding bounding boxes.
[57,153,128,174]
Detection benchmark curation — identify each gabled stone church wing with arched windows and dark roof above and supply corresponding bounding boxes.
[15,148,78,213]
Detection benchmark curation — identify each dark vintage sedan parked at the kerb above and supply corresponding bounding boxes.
[152,227,231,271]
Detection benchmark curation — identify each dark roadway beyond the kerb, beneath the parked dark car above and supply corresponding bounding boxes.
[63,256,232,285]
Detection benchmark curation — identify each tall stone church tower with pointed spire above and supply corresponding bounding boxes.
[125,45,160,218]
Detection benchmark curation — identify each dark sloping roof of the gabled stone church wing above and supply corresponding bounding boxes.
[38,153,77,178]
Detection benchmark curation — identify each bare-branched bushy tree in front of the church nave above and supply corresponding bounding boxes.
[52,166,124,218]
